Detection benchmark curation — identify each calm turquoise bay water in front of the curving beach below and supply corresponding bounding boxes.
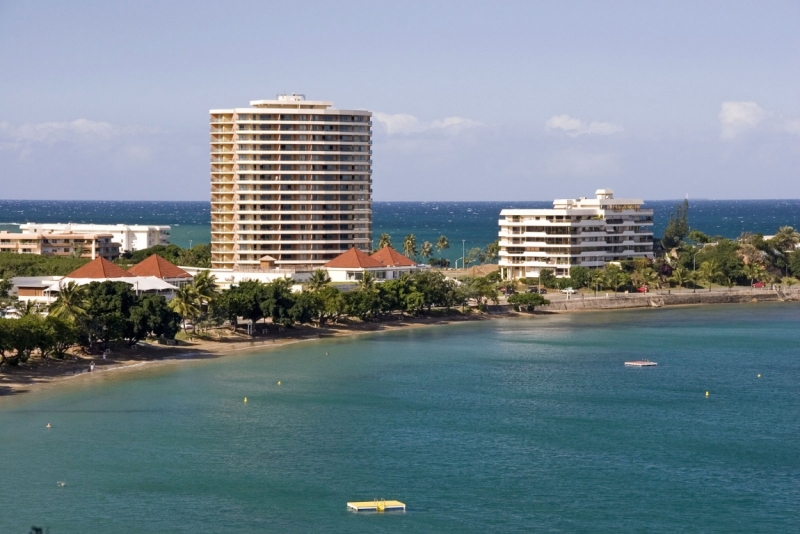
[0,304,800,534]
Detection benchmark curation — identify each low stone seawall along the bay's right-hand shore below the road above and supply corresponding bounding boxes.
[536,290,800,313]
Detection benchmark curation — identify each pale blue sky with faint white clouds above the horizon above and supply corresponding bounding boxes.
[0,0,800,201]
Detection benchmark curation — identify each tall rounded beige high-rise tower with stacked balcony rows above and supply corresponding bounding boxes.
[210,94,372,272]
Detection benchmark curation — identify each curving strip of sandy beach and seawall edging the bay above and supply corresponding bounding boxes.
[0,291,800,399]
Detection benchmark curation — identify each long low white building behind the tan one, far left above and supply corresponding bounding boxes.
[20,223,170,252]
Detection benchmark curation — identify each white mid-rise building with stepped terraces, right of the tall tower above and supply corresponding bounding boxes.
[499,189,653,280]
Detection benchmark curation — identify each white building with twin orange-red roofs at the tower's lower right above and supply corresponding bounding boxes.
[322,247,418,282]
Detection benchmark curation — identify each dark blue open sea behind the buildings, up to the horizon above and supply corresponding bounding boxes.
[0,200,800,260]
